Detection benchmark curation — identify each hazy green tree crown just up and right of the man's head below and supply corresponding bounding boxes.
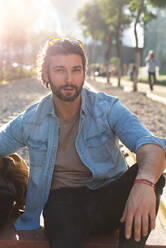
[77,0,131,41]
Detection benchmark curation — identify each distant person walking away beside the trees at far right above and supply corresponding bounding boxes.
[145,50,159,90]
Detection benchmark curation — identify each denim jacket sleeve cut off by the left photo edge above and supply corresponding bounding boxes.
[0,114,25,156]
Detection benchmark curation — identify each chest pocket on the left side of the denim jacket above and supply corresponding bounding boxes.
[28,139,47,167]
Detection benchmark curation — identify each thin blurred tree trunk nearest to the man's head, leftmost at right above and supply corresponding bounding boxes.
[105,33,113,83]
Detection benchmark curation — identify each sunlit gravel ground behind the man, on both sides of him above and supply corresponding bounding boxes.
[0,79,166,162]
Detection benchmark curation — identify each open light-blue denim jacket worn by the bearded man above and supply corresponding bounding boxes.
[0,89,166,230]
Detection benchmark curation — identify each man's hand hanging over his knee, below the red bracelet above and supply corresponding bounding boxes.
[121,183,156,241]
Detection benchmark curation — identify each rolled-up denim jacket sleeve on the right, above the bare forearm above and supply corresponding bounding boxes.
[109,100,166,153]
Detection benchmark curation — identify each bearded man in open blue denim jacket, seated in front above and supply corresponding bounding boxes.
[0,38,166,248]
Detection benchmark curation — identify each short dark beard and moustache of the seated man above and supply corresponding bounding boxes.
[49,79,84,102]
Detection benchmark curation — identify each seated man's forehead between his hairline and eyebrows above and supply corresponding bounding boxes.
[50,54,82,66]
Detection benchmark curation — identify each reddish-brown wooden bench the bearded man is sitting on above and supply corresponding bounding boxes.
[0,214,166,248]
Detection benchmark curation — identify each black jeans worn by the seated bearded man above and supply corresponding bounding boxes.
[43,164,165,248]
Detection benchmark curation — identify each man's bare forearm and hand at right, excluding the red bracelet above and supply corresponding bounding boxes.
[121,144,166,241]
